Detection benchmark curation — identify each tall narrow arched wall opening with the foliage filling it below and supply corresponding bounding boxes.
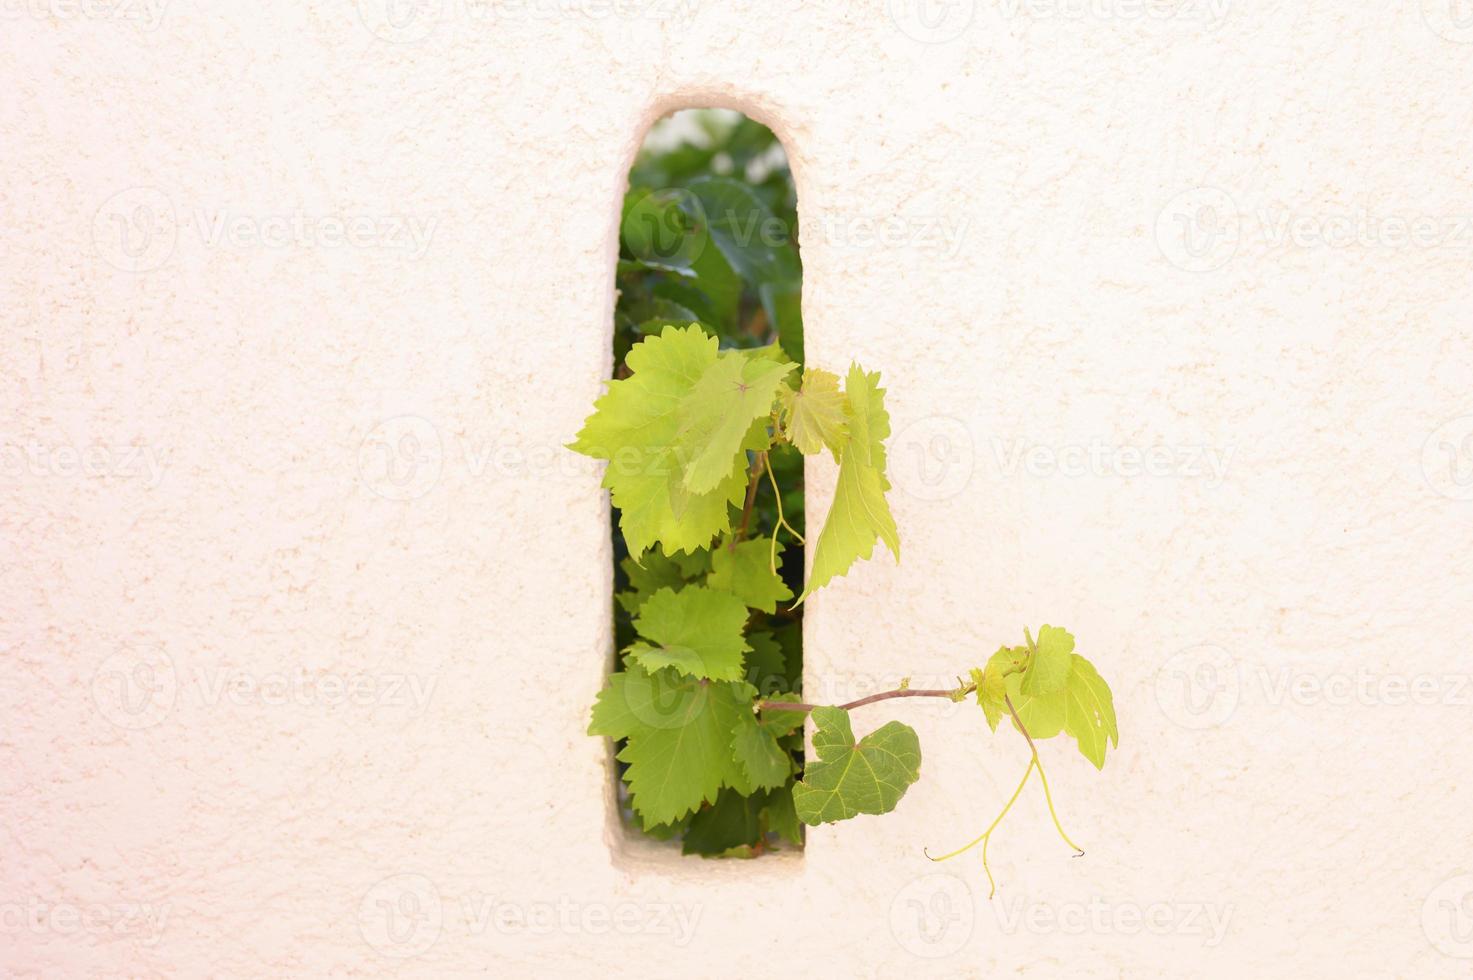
[595,109,804,858]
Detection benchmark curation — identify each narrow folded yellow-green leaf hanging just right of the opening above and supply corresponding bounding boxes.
[798,364,900,603]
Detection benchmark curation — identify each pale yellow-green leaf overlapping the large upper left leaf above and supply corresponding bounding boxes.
[676,351,797,494]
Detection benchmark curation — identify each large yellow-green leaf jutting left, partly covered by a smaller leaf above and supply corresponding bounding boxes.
[570,324,747,556]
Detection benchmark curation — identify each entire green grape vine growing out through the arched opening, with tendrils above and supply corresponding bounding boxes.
[570,110,1119,883]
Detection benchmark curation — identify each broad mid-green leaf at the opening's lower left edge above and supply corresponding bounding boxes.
[588,665,756,827]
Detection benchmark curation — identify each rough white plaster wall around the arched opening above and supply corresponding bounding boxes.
[0,0,1473,977]
